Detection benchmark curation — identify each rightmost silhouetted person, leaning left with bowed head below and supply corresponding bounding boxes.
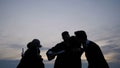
[75,30,109,68]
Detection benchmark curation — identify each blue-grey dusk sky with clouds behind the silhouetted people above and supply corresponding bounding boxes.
[0,0,120,68]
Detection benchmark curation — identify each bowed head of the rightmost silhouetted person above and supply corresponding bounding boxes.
[74,30,87,42]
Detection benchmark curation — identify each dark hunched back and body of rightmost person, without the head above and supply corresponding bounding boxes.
[85,41,109,68]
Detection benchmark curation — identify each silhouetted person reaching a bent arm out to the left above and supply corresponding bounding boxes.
[46,31,70,68]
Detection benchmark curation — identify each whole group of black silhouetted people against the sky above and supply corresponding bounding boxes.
[17,30,109,68]
